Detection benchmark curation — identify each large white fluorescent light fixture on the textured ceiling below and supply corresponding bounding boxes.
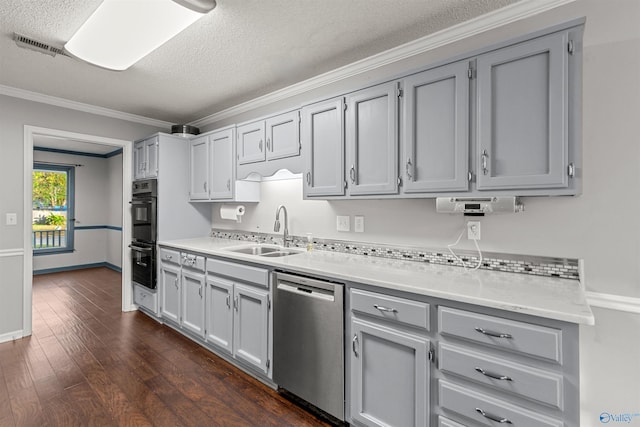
[64,0,216,71]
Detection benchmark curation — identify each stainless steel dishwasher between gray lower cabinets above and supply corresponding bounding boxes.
[273,273,344,421]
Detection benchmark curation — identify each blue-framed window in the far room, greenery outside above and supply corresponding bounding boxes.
[31,163,75,255]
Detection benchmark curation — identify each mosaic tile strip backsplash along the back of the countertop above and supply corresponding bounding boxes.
[210,229,579,280]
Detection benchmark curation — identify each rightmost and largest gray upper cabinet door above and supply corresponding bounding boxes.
[477,33,569,190]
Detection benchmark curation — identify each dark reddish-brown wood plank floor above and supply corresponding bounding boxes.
[0,268,326,427]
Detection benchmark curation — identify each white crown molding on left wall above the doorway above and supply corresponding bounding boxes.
[0,85,172,128]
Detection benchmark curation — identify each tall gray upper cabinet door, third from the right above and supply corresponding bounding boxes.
[347,82,398,195]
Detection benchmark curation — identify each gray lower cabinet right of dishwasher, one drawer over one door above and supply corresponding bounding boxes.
[349,289,430,427]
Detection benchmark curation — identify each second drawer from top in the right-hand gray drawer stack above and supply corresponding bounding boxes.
[438,343,563,410]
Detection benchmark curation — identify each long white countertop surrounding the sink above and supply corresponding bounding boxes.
[159,237,595,325]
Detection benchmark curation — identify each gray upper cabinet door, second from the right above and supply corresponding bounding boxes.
[402,61,469,193]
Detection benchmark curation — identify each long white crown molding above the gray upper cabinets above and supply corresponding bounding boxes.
[190,0,576,126]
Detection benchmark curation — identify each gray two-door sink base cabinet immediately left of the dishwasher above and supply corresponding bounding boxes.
[205,259,271,378]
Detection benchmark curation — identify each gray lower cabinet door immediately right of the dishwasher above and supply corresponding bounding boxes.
[351,319,429,427]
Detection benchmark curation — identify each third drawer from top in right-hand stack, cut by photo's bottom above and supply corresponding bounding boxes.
[438,380,563,427]
